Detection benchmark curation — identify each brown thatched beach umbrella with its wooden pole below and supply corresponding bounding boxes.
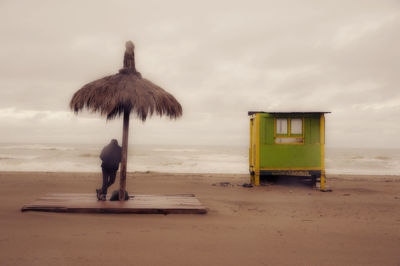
[70,41,182,200]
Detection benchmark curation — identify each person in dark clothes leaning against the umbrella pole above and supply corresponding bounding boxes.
[96,139,122,200]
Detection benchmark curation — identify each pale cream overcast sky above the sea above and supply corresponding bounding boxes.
[0,0,400,148]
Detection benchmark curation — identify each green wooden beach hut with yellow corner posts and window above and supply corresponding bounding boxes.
[248,111,329,190]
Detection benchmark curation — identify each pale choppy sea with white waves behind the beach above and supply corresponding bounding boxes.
[0,143,400,175]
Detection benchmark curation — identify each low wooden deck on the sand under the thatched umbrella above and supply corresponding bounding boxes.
[21,193,207,214]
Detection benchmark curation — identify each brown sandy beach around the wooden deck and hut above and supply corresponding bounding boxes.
[0,172,400,265]
